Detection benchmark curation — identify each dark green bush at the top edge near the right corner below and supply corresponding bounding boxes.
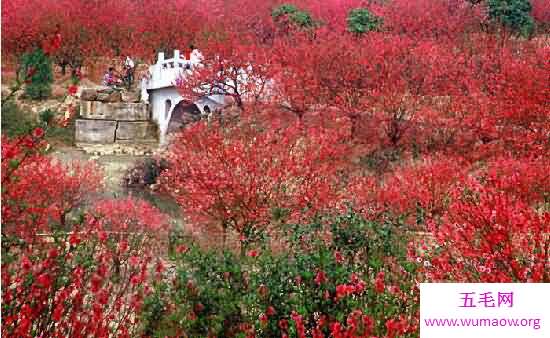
[487,0,535,36]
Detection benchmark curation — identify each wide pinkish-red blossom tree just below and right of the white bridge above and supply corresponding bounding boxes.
[161,119,352,248]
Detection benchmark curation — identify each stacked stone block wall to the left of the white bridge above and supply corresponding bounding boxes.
[75,88,157,144]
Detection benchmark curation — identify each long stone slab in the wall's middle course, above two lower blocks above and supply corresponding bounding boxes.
[80,101,149,121]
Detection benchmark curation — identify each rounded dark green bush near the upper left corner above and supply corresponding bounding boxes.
[18,49,53,100]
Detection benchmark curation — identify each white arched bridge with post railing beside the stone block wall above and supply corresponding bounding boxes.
[141,49,224,144]
